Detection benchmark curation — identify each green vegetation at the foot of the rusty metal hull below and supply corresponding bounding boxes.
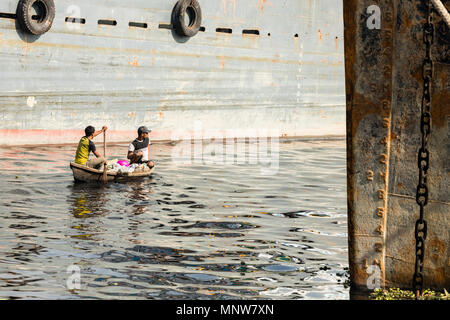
[370,288,450,300]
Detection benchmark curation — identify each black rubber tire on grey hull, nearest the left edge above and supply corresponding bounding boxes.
[17,0,55,36]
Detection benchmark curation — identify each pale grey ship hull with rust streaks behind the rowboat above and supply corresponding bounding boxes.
[0,0,345,145]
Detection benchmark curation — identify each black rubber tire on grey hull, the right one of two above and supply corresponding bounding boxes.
[172,0,202,37]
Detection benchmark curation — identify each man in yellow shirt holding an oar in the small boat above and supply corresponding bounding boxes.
[75,126,108,170]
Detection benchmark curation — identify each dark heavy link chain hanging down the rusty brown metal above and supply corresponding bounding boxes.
[413,0,434,298]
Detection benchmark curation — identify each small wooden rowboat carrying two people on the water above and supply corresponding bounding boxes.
[70,162,155,182]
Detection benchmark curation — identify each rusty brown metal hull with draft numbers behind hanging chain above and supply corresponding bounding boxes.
[344,0,450,289]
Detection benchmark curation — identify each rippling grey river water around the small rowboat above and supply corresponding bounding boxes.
[0,140,349,299]
